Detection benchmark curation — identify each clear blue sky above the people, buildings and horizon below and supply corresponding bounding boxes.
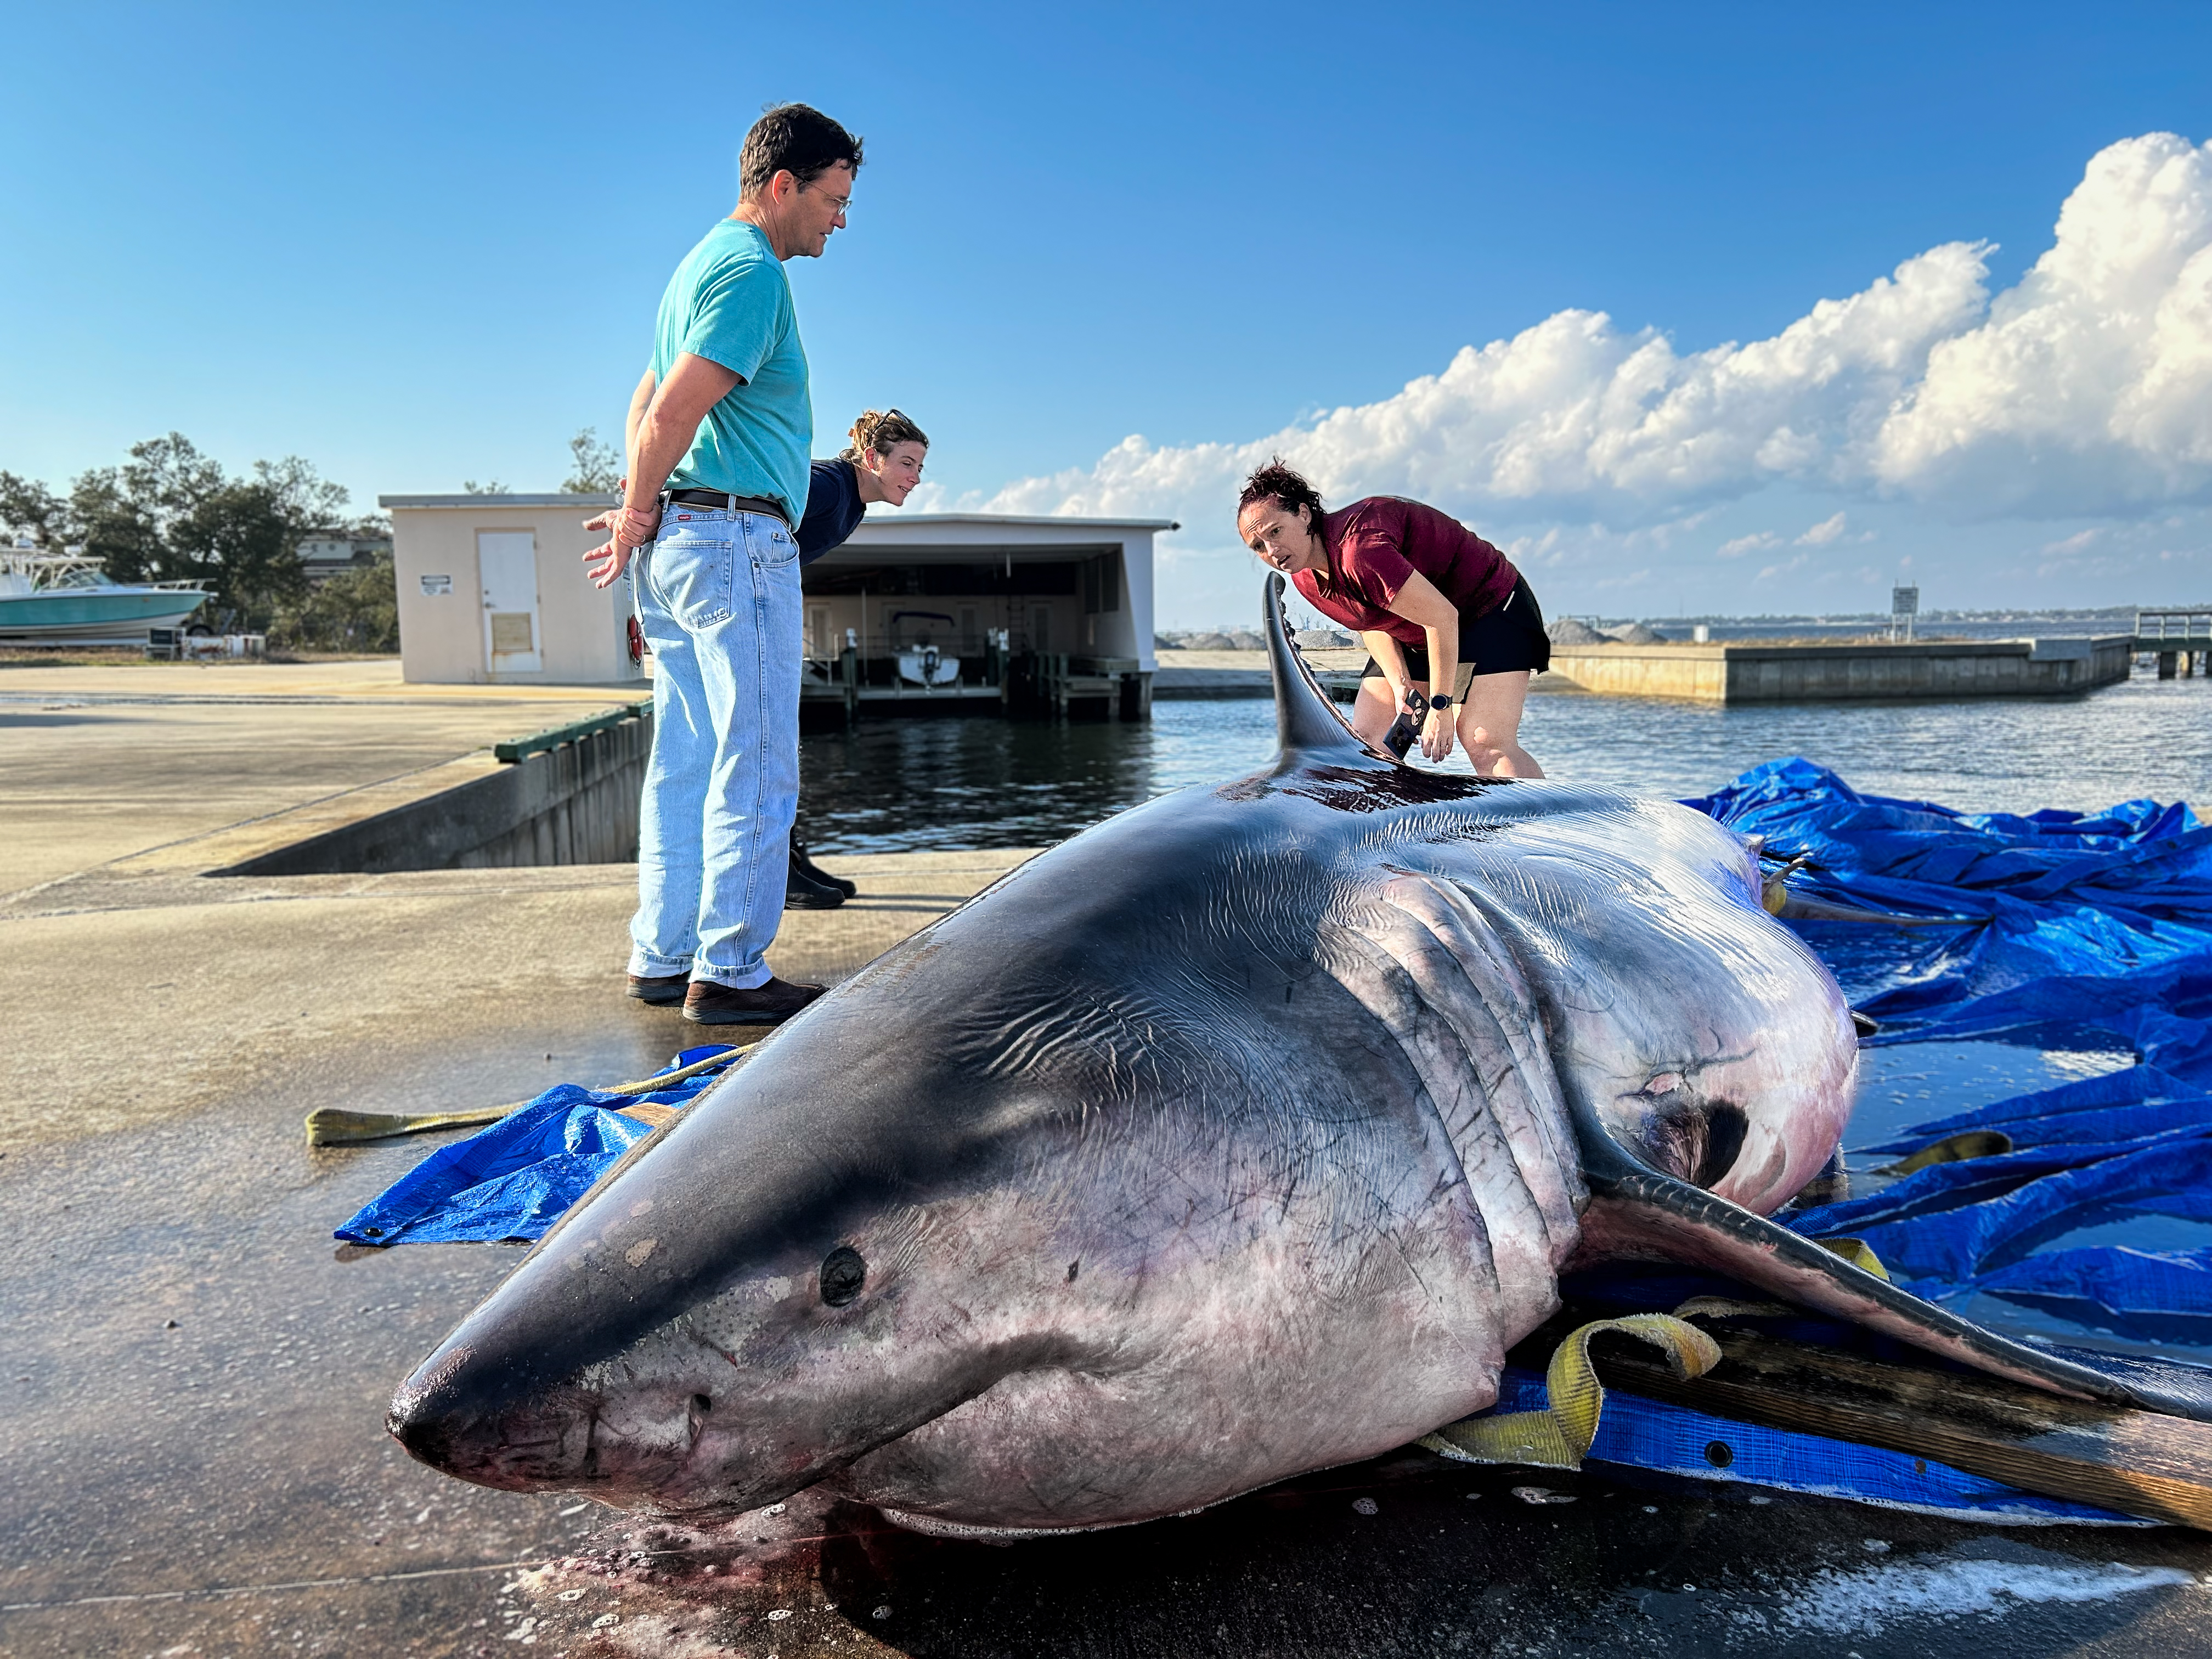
[0,4,2212,626]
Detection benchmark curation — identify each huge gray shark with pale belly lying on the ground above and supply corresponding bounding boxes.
[390,584,2176,1533]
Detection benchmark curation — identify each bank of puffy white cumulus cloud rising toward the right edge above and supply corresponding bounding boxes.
[960,133,2212,546]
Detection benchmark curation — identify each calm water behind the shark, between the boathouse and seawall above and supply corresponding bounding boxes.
[799,675,2212,851]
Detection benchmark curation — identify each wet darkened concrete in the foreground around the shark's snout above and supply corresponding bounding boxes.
[13,924,2212,1659]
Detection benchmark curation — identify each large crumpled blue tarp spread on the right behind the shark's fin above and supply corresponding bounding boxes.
[1690,759,2212,1345]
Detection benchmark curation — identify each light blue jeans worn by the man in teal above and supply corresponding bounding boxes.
[630,502,801,986]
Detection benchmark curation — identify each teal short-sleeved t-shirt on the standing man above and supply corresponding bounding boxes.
[652,219,814,527]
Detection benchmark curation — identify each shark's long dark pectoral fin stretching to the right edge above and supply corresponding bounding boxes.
[1584,1159,2212,1420]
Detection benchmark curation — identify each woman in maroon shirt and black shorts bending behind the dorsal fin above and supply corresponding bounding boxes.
[1237,460,1550,778]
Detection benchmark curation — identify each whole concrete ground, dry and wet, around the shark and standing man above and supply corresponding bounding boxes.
[0,664,2212,1659]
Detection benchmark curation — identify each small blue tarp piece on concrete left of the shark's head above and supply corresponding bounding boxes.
[336,1044,730,1245]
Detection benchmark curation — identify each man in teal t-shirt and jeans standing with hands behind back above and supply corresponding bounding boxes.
[584,104,860,1024]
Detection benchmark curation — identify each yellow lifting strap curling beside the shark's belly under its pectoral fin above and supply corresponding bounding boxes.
[1413,1239,1889,1469]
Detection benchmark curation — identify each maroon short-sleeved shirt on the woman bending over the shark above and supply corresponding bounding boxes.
[1290,495,1520,646]
